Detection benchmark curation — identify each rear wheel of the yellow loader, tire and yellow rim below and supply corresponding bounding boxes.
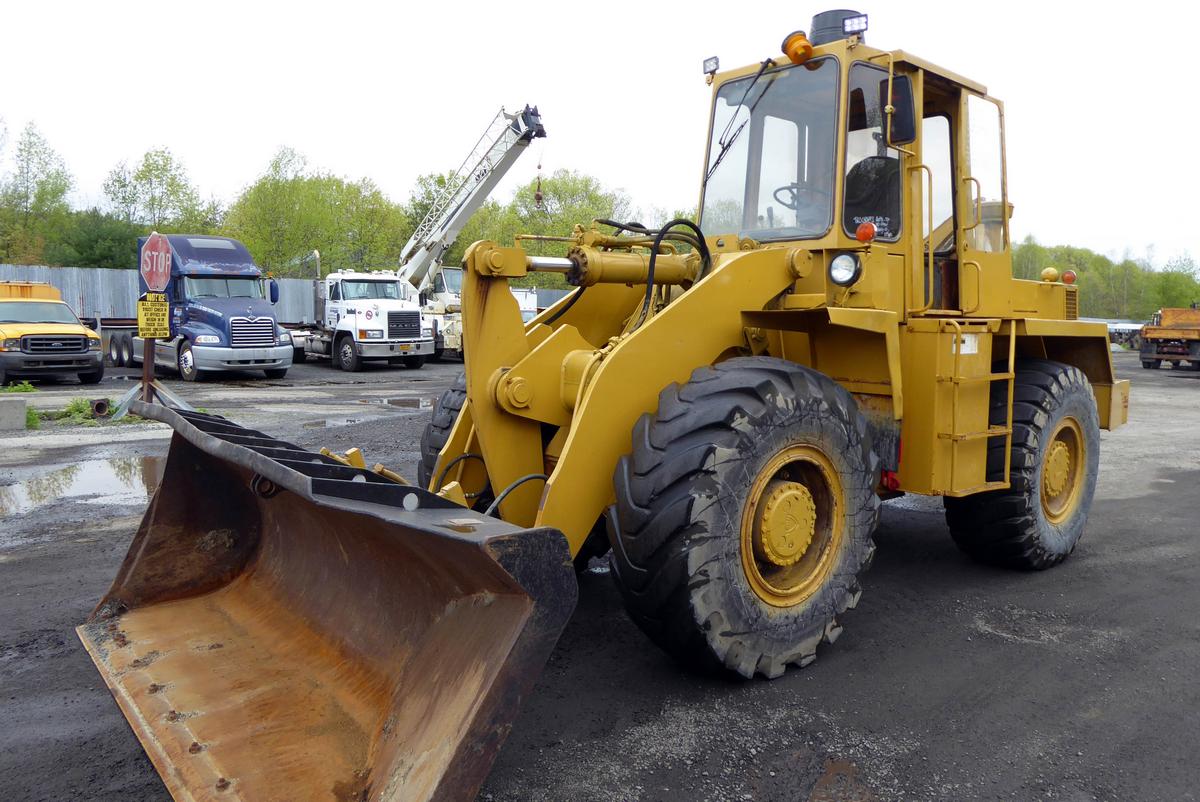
[944,359,1100,570]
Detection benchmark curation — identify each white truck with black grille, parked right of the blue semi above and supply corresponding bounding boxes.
[292,270,433,371]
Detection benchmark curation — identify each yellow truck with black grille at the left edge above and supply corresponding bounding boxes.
[0,281,104,387]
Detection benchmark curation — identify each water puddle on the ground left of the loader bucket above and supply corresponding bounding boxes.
[0,456,164,519]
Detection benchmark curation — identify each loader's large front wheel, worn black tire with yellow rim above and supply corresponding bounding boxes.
[608,357,880,678]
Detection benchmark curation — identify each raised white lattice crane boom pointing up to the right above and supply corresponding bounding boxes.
[400,106,546,292]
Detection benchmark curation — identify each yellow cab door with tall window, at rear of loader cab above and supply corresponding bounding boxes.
[955,89,1013,317]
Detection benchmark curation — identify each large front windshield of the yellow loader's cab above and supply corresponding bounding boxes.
[701,56,838,240]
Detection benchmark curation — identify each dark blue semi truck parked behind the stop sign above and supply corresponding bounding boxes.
[123,234,293,382]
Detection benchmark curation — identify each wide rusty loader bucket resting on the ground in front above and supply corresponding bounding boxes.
[78,403,577,801]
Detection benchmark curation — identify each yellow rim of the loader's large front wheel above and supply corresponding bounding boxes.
[742,445,845,608]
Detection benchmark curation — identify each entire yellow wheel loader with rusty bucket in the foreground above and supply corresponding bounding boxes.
[79,11,1129,801]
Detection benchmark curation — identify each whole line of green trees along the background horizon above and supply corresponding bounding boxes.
[0,120,1200,321]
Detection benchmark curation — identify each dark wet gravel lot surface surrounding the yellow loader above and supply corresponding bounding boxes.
[0,353,1200,802]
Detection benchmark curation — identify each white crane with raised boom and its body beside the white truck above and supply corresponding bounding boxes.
[400,106,546,357]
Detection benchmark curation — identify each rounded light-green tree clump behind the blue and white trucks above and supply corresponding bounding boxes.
[222,148,410,275]
